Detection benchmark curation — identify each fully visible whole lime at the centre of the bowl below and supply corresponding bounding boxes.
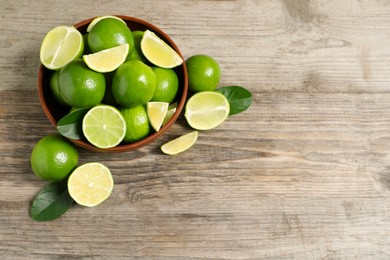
[112,60,157,107]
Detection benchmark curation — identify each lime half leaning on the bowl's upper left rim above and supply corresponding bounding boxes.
[39,26,84,70]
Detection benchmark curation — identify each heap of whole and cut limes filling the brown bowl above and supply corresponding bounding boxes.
[40,16,183,149]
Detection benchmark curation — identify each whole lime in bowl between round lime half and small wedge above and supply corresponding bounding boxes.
[120,105,150,143]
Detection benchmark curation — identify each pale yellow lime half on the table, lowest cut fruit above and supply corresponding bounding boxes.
[68,162,114,207]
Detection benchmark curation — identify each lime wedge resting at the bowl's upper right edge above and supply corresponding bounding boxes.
[141,30,183,69]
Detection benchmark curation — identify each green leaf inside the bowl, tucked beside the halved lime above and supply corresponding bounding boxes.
[57,108,89,139]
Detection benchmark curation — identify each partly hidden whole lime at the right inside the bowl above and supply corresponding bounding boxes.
[151,67,179,103]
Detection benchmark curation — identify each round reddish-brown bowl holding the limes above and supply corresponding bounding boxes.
[38,15,188,152]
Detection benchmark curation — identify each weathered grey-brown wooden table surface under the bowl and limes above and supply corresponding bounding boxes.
[0,0,390,259]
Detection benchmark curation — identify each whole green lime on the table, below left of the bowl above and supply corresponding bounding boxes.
[31,135,79,181]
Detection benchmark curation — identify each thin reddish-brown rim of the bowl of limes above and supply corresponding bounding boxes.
[38,15,188,153]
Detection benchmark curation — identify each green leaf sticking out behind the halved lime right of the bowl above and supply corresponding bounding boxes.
[217,86,252,115]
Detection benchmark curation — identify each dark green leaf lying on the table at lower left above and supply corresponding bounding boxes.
[30,181,73,221]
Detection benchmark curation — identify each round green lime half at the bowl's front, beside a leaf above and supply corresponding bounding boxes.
[82,105,126,149]
